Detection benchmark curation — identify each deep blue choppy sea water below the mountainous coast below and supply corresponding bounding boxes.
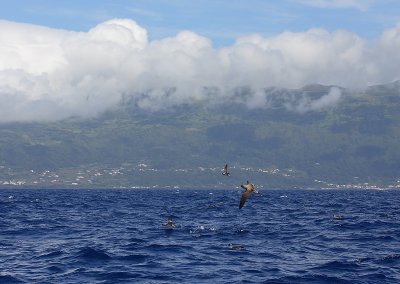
[0,189,400,283]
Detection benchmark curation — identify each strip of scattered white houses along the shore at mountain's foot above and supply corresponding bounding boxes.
[0,162,400,190]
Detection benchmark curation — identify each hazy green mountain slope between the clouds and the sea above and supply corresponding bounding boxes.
[0,82,400,188]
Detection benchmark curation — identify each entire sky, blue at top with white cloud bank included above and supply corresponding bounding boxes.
[0,0,400,122]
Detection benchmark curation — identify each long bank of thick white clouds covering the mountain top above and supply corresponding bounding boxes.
[0,19,400,122]
